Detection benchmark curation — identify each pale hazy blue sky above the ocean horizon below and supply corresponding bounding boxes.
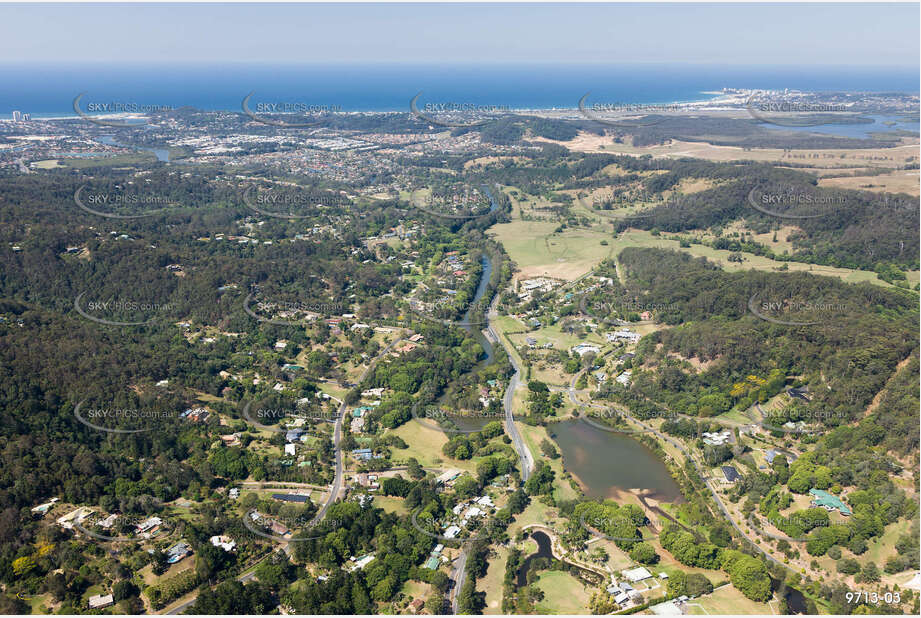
[0,3,921,67]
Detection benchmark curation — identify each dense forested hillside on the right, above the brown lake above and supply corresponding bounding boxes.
[599,248,918,442]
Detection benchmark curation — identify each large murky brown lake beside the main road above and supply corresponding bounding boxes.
[548,419,683,502]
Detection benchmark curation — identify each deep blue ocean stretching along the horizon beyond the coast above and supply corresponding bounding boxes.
[0,63,919,118]
